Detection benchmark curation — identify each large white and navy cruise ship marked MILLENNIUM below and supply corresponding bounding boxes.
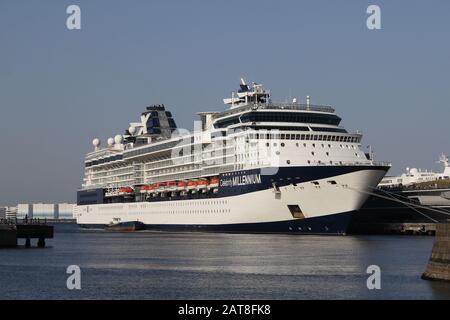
[74,79,390,234]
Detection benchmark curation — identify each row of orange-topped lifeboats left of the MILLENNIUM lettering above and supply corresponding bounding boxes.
[140,177,219,195]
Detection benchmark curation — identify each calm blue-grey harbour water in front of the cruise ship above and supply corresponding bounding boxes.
[0,225,450,299]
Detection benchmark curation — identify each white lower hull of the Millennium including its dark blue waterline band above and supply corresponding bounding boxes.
[75,166,387,234]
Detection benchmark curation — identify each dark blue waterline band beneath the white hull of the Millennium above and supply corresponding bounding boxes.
[80,212,353,234]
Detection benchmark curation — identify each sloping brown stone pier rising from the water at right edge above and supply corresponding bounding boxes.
[422,222,450,281]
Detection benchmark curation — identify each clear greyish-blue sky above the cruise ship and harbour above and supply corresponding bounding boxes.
[0,0,450,204]
